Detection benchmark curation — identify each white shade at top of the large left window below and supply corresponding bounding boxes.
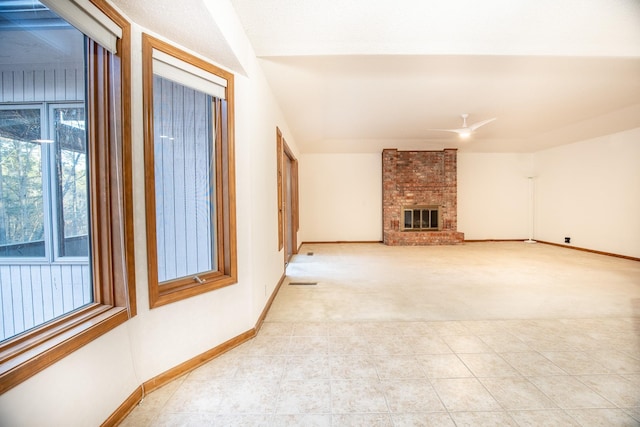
[40,0,122,53]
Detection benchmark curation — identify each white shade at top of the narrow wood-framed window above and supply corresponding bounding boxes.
[153,49,227,99]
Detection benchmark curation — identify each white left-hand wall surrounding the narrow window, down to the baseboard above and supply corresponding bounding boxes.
[0,2,297,426]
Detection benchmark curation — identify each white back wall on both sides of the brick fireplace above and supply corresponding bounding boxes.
[300,153,532,242]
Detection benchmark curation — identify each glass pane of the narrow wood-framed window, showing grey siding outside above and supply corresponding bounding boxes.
[153,76,217,282]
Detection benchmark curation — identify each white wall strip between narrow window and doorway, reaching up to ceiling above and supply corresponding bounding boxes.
[205,1,300,321]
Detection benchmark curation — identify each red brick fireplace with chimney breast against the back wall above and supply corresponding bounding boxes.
[382,149,464,246]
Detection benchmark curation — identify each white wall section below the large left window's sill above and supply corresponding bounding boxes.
[0,326,139,427]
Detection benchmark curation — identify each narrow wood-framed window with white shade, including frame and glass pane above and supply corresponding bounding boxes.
[142,34,237,307]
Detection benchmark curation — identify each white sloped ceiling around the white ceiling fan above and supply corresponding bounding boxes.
[230,0,640,152]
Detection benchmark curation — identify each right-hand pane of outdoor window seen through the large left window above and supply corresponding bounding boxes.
[53,107,89,257]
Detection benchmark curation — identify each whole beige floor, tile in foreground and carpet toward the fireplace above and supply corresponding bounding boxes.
[123,242,640,427]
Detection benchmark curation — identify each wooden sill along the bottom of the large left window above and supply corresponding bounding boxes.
[0,304,129,394]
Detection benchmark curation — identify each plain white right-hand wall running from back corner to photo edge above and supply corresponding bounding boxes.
[534,128,640,258]
